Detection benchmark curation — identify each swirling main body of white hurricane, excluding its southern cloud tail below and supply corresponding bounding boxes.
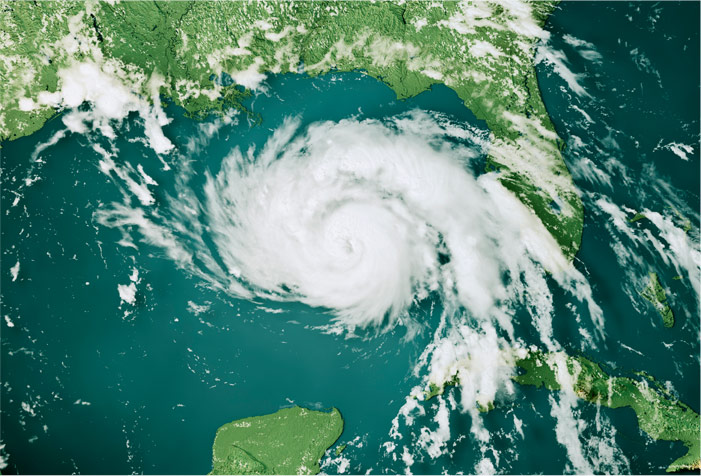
[98,111,592,336]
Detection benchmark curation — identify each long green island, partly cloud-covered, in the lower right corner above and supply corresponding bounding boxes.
[514,351,701,472]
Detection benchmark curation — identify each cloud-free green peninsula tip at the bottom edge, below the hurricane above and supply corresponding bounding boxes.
[210,407,343,474]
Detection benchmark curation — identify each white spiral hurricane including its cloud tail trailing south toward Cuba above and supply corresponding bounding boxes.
[93,111,603,468]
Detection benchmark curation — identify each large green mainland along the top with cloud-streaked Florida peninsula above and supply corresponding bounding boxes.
[0,1,583,259]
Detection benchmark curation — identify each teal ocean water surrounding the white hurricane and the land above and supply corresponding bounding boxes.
[0,2,701,474]
